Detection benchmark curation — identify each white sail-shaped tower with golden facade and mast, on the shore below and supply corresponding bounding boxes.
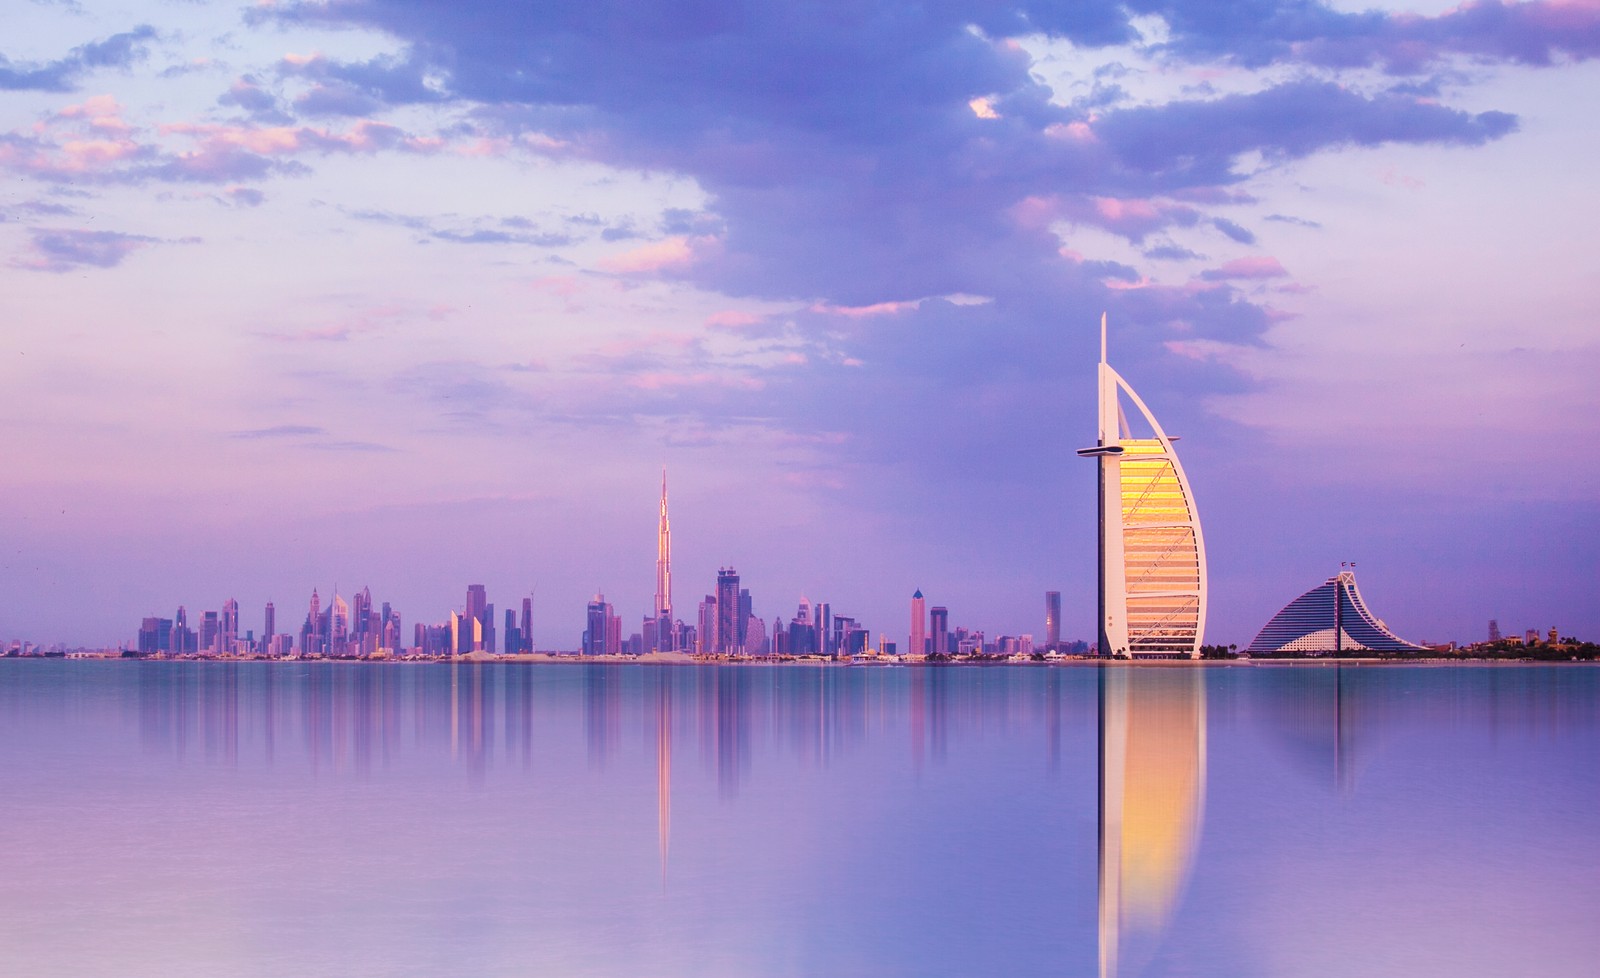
[1078,314,1206,658]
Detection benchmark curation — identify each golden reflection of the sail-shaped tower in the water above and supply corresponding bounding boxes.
[1099,666,1206,978]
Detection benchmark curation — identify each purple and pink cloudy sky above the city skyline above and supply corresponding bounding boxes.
[0,0,1600,648]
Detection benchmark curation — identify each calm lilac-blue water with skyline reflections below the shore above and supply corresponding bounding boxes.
[0,659,1600,978]
